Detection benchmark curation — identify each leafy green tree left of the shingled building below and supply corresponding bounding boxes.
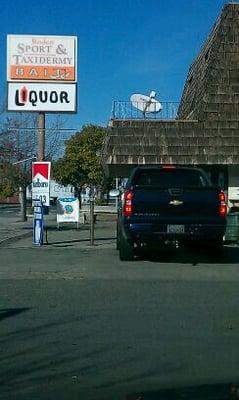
[53,125,106,200]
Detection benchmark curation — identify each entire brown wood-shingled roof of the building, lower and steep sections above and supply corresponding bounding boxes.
[104,3,239,176]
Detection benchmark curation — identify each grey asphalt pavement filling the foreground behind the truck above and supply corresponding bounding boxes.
[0,239,239,400]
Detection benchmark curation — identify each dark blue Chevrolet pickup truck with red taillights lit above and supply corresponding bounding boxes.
[113,165,227,260]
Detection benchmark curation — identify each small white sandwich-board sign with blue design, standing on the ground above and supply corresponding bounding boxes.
[57,197,80,224]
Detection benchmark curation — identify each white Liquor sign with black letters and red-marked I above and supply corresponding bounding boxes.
[8,82,76,112]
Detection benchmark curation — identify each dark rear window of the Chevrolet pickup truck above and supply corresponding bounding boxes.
[134,169,209,187]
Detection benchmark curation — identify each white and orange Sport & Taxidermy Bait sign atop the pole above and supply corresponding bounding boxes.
[7,35,77,82]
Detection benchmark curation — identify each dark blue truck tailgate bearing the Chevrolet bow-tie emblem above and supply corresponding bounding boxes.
[132,187,220,224]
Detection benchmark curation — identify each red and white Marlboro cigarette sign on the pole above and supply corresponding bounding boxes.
[32,161,51,207]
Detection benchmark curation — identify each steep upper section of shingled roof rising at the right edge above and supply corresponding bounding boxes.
[179,3,239,121]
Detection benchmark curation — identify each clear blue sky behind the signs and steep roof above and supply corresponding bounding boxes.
[0,0,232,129]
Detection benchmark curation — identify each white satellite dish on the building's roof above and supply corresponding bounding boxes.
[130,90,163,114]
